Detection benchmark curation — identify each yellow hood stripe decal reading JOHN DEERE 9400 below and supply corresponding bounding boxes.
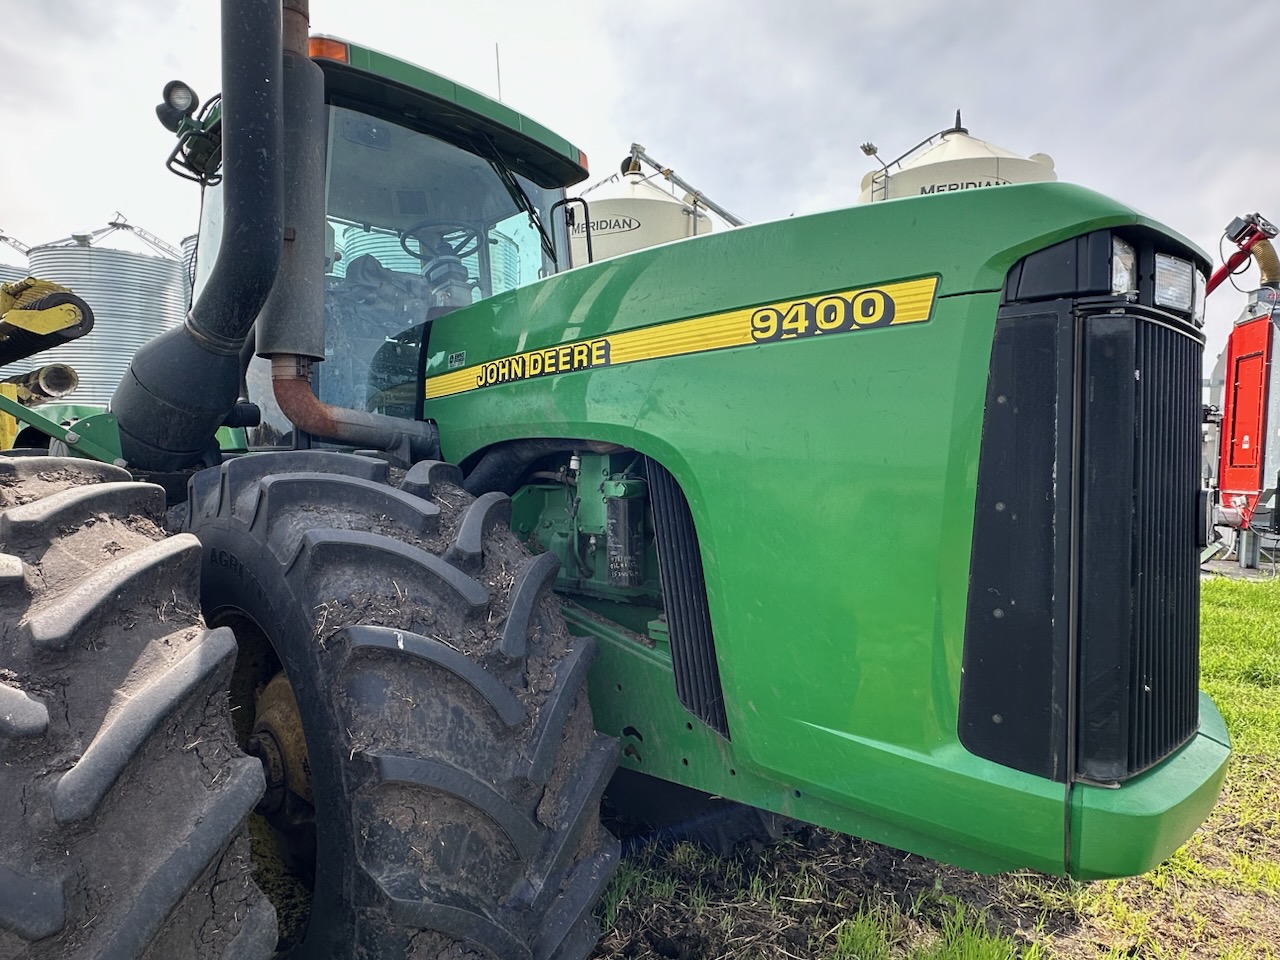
[426,276,938,399]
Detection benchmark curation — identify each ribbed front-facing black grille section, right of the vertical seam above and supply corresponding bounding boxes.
[1076,316,1202,781]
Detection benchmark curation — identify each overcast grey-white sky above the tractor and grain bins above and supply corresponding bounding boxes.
[0,0,1280,358]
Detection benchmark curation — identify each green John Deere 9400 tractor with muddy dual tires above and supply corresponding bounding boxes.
[0,0,1229,960]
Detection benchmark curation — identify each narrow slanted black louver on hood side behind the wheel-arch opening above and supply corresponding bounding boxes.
[645,457,728,739]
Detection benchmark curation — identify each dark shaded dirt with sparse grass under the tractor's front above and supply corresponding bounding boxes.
[593,824,1036,960]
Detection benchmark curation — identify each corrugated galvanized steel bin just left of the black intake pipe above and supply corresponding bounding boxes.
[23,234,185,406]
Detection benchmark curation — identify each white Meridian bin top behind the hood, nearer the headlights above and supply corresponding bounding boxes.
[858,126,1057,204]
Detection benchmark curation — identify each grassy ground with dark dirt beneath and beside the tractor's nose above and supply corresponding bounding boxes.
[595,577,1280,960]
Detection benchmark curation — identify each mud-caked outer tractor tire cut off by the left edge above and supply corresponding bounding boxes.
[0,457,275,960]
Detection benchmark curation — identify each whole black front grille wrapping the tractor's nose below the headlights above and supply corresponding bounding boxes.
[959,300,1203,783]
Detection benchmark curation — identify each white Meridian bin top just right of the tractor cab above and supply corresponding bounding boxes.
[570,173,712,266]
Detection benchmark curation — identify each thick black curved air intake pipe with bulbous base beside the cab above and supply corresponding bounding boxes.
[111,0,283,471]
